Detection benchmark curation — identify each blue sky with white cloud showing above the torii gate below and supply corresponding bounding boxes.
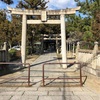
[0,0,84,10]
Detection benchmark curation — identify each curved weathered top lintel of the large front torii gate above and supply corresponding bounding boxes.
[8,6,80,15]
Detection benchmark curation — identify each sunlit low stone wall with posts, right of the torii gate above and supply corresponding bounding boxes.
[76,42,100,77]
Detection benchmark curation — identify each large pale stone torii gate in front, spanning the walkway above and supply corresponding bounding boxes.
[8,7,80,68]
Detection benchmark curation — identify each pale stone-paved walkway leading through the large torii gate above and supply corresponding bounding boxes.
[0,53,100,100]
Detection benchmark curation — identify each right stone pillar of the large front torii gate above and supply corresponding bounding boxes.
[61,14,67,68]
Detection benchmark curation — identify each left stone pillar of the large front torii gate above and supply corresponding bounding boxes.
[21,14,27,63]
